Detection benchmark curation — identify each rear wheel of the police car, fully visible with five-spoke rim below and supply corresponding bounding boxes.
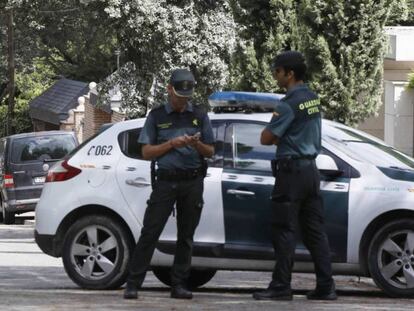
[62,215,132,289]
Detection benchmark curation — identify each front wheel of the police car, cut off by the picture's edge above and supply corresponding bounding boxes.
[368,219,414,297]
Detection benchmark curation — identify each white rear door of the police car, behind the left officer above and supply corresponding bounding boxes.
[117,123,224,247]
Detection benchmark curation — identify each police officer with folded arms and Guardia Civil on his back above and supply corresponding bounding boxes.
[253,51,337,300]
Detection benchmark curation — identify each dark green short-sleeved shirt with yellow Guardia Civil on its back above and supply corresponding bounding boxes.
[266,84,321,159]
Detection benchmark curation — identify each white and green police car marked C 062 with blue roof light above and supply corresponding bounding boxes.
[35,92,414,297]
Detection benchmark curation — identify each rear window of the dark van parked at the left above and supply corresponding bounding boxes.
[11,135,76,163]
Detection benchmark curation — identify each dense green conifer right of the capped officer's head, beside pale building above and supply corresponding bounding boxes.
[298,0,393,124]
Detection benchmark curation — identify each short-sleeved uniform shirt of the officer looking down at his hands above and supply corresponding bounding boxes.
[138,103,215,170]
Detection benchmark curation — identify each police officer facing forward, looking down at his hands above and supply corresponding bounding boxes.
[124,69,214,299]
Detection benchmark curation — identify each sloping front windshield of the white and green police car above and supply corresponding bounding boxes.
[323,125,414,169]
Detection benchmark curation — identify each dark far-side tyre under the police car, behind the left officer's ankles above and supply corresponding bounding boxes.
[152,267,216,289]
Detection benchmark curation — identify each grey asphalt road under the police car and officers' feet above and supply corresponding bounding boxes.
[0,217,414,311]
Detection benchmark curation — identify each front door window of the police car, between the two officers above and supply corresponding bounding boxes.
[224,122,276,171]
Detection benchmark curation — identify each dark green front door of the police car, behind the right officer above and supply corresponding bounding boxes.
[222,121,349,261]
